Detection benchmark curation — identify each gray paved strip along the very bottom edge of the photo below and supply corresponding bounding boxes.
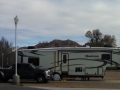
[0,83,120,90]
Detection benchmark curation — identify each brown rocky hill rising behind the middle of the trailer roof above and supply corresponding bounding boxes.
[35,39,81,48]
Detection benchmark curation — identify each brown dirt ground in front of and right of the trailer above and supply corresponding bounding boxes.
[22,70,120,89]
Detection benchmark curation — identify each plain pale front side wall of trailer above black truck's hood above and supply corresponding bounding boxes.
[18,51,56,69]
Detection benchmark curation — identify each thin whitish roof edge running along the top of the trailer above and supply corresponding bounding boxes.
[19,47,119,51]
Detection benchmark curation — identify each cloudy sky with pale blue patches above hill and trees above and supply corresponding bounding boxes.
[0,0,120,47]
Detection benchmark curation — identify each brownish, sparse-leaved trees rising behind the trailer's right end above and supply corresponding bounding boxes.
[85,29,116,47]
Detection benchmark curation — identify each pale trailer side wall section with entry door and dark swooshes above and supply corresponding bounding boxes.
[56,51,114,76]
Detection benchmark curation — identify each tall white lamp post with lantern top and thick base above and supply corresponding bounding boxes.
[13,16,20,85]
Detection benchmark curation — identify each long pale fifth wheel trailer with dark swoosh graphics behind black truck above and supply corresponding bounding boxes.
[18,47,120,80]
